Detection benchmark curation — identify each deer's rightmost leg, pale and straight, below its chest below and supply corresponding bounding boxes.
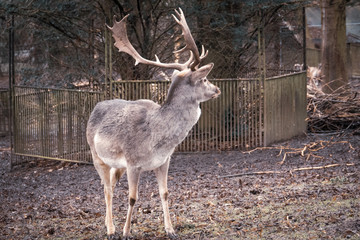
[154,158,176,238]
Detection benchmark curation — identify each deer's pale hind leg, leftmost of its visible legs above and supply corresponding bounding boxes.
[92,153,125,235]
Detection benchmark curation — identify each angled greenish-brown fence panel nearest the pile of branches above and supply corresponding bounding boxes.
[264,73,307,146]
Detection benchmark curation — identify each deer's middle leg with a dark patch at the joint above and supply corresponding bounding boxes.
[123,168,140,239]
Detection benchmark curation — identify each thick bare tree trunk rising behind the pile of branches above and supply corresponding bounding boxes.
[321,0,348,93]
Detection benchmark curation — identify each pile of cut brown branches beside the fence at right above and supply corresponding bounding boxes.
[307,80,360,134]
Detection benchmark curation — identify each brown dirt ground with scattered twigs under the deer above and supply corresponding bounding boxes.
[0,132,360,240]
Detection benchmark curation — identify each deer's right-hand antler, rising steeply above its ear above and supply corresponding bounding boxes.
[172,8,202,71]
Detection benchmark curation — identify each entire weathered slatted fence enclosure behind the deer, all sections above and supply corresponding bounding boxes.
[9,73,306,164]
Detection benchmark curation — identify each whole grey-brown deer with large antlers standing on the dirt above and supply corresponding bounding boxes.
[86,8,221,239]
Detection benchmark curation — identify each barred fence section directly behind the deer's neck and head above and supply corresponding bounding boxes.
[113,79,263,152]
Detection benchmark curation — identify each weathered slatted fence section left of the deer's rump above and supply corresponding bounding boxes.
[12,87,102,165]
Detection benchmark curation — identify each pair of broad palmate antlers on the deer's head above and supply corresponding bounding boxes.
[107,8,208,71]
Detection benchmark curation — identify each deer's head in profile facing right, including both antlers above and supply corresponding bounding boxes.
[108,8,221,102]
